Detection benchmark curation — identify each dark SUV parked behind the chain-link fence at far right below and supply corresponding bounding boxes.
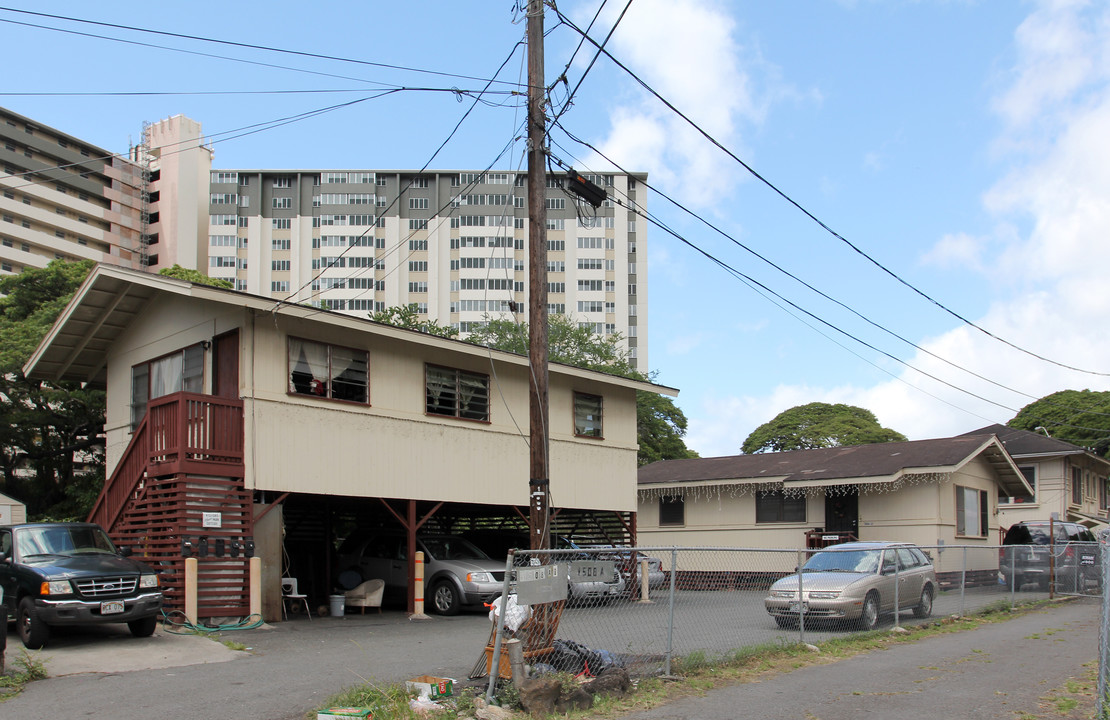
[998,520,1102,595]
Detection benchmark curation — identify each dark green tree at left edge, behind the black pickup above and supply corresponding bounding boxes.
[0,261,104,519]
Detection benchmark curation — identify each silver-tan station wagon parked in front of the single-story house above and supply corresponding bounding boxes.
[764,542,938,630]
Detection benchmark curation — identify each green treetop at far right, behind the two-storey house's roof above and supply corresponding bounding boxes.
[1007,391,1110,457]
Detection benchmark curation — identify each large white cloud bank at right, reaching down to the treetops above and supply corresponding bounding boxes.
[687,1,1110,455]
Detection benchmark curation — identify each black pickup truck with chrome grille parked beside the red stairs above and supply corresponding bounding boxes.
[0,523,162,650]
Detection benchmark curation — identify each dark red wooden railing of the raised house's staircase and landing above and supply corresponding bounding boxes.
[89,393,243,533]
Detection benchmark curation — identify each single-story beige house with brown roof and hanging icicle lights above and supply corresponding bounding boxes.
[637,435,1031,581]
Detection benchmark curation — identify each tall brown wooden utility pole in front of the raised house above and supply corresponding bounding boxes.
[527,0,551,550]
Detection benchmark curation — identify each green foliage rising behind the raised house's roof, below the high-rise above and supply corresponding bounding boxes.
[370,307,697,465]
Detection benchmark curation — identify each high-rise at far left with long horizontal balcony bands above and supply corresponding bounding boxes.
[0,108,150,274]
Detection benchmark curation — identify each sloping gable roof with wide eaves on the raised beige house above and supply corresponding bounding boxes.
[23,264,678,396]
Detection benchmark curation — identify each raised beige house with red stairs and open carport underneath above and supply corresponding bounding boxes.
[24,265,677,619]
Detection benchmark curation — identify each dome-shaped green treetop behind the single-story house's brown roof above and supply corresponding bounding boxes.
[740,403,906,455]
